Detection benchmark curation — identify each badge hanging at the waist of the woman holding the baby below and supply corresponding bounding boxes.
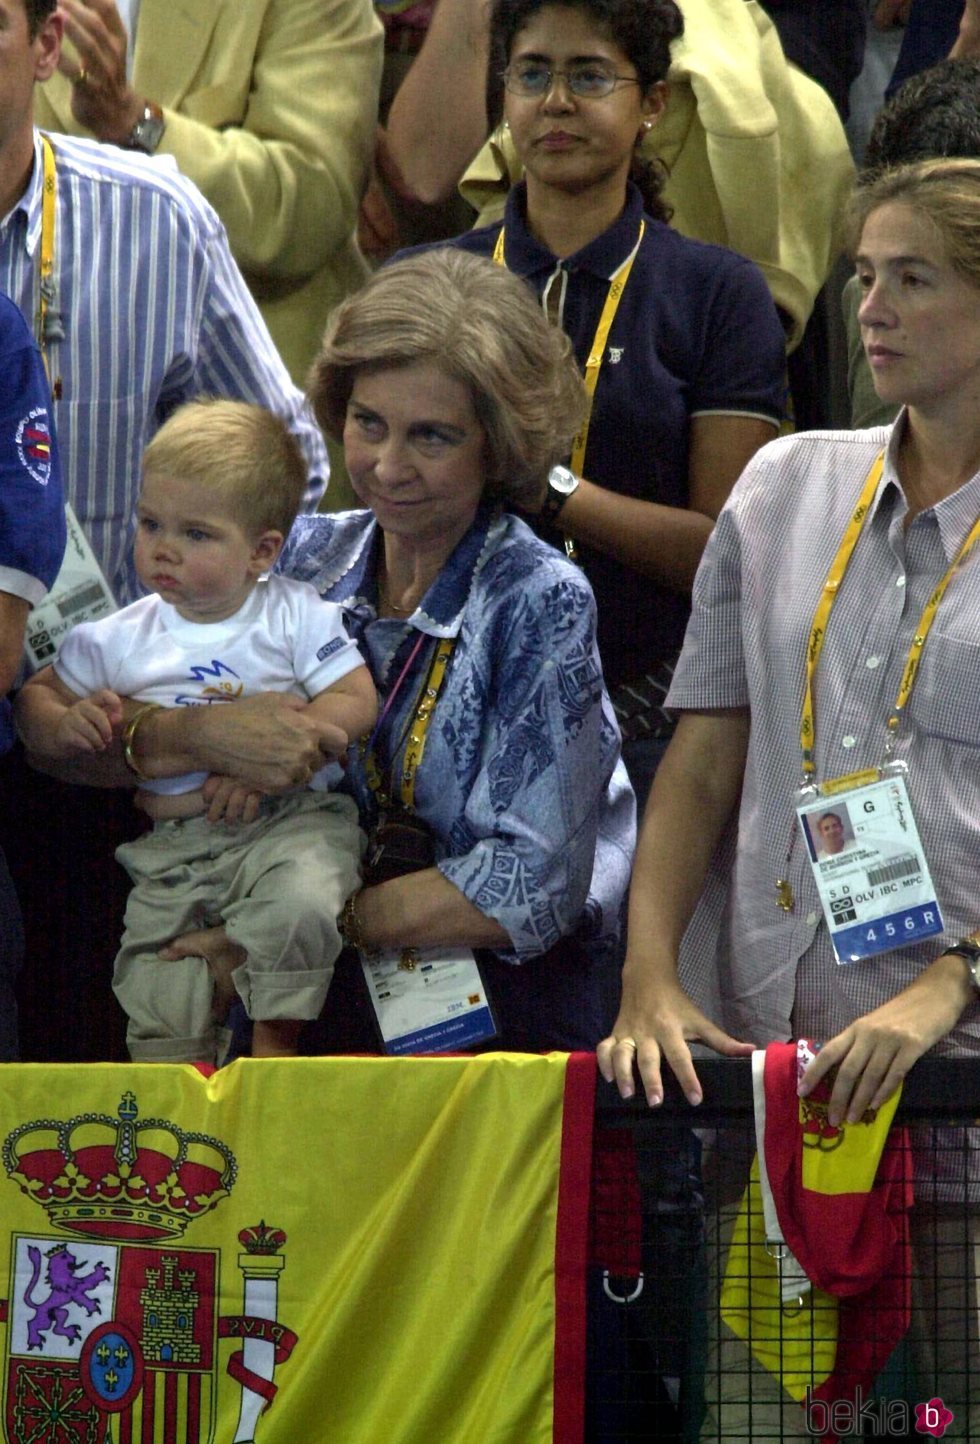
[361,947,496,1054]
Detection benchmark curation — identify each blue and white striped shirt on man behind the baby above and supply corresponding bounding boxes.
[0,131,329,604]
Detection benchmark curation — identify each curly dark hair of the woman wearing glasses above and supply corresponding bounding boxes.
[486,0,684,221]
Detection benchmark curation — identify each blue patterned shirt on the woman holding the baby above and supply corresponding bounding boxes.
[280,508,635,962]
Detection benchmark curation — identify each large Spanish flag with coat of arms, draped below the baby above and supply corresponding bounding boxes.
[0,1054,595,1444]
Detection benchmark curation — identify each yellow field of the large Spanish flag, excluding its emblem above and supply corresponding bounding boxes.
[0,1053,567,1444]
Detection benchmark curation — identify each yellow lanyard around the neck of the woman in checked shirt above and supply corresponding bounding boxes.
[800,452,980,781]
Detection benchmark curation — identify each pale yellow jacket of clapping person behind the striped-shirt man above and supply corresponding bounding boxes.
[35,0,382,384]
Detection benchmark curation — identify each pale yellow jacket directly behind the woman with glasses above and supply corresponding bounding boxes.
[459,0,854,347]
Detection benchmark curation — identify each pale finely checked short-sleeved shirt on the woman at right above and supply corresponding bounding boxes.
[668,416,980,1097]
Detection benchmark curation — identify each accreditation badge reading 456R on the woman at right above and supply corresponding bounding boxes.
[797,762,942,963]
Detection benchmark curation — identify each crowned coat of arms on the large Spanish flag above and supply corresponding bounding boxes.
[0,1092,294,1444]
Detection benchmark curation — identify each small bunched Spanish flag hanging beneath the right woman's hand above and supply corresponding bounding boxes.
[722,1043,912,1437]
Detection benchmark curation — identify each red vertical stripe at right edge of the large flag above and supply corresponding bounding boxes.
[551,1053,596,1444]
